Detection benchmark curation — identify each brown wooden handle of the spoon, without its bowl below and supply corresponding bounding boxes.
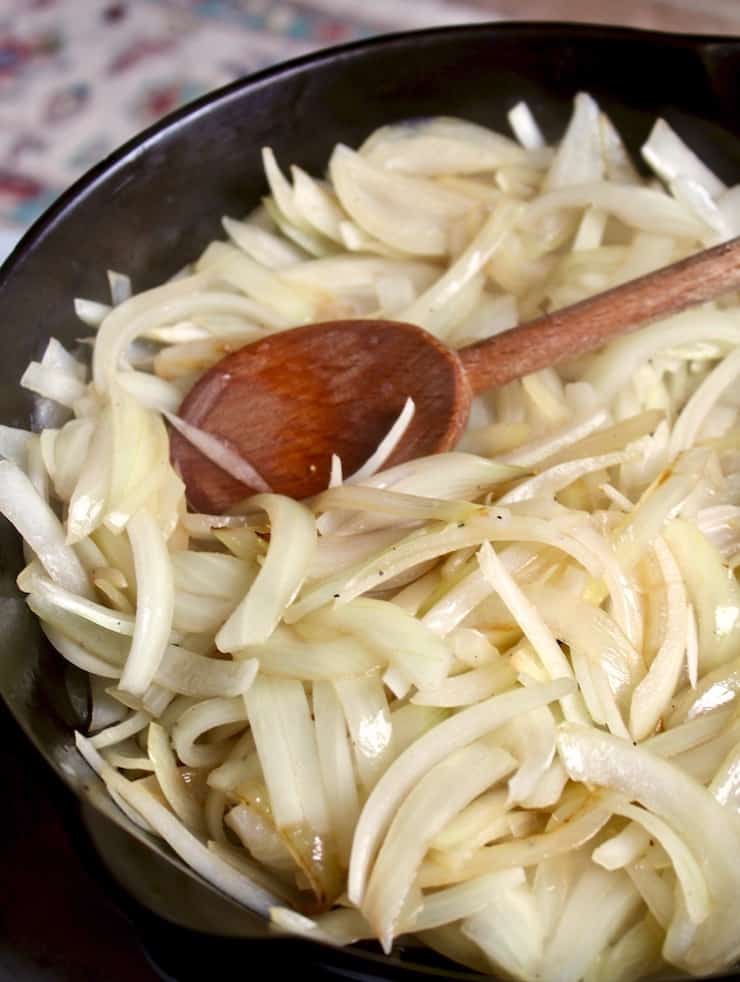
[457,237,740,392]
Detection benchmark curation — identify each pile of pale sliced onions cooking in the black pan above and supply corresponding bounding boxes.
[0,94,740,982]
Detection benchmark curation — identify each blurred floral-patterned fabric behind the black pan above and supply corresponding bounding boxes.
[0,0,740,260]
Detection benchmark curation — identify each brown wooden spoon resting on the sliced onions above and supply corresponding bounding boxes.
[172,238,740,513]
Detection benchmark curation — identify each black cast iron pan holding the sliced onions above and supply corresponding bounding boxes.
[0,23,740,982]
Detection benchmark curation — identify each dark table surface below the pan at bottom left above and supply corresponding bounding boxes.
[0,707,159,982]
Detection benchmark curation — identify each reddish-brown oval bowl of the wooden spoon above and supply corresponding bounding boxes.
[171,320,472,514]
